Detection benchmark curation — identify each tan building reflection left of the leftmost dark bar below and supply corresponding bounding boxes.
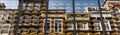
[0,3,19,35]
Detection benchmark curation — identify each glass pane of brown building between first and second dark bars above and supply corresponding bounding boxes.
[19,0,42,35]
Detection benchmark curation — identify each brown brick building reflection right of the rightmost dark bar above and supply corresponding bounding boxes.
[107,0,120,35]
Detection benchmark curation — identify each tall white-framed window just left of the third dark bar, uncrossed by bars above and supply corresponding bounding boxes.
[54,19,63,33]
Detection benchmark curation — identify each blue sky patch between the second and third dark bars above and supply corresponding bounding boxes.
[49,0,72,12]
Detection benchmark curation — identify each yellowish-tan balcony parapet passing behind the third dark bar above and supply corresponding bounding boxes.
[67,13,89,20]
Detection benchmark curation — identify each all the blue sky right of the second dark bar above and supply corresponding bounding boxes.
[49,0,104,12]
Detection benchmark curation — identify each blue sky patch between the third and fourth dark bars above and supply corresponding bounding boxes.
[75,0,97,13]
